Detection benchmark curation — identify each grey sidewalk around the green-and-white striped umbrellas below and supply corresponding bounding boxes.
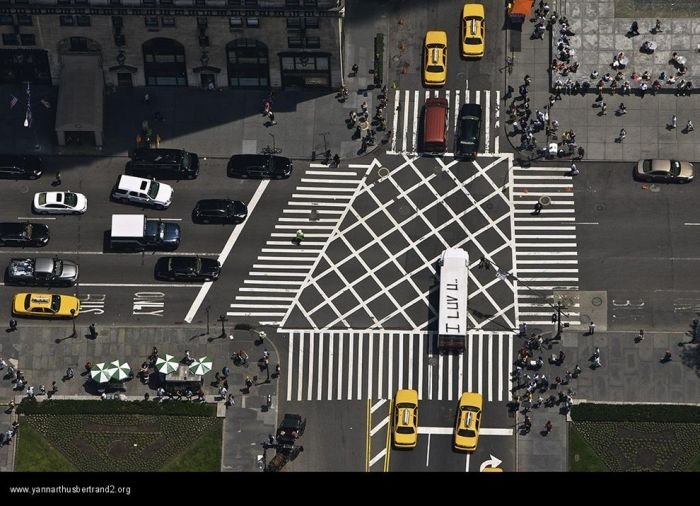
[0,322,284,472]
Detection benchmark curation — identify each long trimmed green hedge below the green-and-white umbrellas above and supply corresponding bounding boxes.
[17,399,216,416]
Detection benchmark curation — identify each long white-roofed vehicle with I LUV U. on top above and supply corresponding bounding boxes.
[437,248,469,353]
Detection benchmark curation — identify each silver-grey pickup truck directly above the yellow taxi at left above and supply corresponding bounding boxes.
[6,257,78,286]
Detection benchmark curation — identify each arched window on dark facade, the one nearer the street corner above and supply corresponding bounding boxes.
[226,39,270,88]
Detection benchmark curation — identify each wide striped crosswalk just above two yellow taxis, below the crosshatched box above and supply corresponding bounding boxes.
[279,329,514,401]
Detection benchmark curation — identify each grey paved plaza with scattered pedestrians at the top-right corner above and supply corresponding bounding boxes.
[503,0,700,161]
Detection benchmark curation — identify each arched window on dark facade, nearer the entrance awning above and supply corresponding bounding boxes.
[143,38,187,86]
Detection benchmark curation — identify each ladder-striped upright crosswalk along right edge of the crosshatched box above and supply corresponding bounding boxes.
[512,167,580,325]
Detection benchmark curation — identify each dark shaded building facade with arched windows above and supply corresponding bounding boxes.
[0,0,344,89]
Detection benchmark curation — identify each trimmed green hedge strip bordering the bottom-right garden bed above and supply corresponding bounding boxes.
[571,403,700,423]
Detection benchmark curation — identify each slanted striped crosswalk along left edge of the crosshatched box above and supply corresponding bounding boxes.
[226,163,366,325]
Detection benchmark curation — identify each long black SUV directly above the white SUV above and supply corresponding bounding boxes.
[126,149,199,179]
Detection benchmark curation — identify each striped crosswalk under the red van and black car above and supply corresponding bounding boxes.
[387,86,501,156]
